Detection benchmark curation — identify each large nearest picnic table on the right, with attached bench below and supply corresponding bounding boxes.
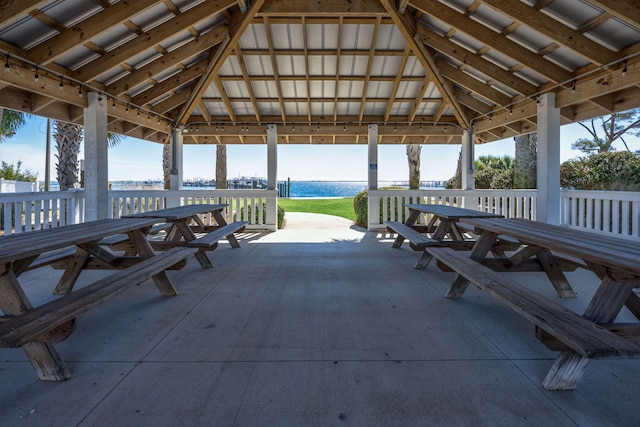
[427,218,640,390]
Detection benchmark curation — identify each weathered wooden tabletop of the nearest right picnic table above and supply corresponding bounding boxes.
[462,218,640,277]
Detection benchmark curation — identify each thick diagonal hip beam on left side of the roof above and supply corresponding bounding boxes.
[177,0,265,124]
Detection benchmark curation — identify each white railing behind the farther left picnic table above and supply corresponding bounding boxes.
[109,190,278,231]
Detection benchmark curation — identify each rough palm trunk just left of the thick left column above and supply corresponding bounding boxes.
[53,120,83,191]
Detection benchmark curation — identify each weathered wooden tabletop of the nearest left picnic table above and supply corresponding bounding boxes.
[0,218,162,264]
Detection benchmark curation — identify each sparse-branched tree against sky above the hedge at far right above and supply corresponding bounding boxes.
[571,109,640,154]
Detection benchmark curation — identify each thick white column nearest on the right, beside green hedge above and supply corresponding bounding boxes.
[536,93,560,224]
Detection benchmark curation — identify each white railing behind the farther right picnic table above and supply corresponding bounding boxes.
[368,190,536,230]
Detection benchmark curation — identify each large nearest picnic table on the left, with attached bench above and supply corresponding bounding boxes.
[0,218,196,381]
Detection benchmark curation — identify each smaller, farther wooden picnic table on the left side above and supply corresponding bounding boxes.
[123,204,247,268]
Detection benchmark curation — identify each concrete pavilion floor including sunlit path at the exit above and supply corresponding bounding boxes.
[0,213,640,426]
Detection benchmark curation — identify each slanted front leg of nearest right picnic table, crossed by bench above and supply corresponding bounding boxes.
[542,276,634,390]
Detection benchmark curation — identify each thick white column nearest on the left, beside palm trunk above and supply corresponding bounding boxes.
[84,92,109,221]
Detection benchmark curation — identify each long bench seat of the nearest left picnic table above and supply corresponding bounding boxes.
[0,247,197,347]
